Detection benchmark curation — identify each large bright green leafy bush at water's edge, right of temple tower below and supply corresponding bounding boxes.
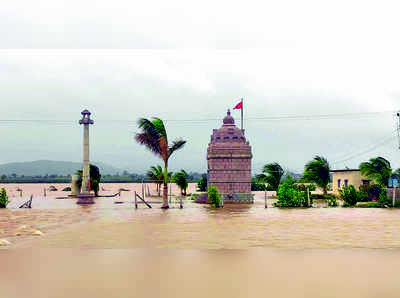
[276,176,307,207]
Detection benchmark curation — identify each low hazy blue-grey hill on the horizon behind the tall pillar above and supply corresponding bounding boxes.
[0,160,122,176]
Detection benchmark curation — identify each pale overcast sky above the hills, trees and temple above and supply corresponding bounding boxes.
[0,0,400,172]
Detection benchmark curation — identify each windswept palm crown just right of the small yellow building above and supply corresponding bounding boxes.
[360,156,392,186]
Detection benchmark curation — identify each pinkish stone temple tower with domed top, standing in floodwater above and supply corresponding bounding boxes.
[207,110,254,204]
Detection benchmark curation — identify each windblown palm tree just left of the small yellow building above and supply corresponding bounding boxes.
[303,155,331,195]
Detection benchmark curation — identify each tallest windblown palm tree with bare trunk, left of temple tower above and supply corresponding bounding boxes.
[135,118,186,209]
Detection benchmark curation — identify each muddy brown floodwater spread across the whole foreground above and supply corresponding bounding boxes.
[0,183,400,298]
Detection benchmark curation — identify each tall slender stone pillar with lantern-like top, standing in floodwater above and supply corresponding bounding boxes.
[77,110,94,204]
